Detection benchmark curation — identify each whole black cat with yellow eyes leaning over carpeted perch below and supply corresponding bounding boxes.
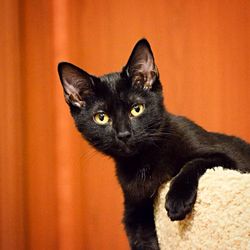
[58,39,250,250]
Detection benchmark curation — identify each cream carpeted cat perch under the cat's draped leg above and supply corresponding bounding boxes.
[155,168,250,250]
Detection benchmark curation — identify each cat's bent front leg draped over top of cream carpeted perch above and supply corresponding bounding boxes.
[165,153,234,221]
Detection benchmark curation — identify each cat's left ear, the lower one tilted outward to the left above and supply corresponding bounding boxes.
[58,62,94,108]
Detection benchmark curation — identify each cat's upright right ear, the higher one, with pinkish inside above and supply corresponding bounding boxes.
[124,39,158,89]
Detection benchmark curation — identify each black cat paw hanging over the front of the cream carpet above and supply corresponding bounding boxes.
[165,177,197,221]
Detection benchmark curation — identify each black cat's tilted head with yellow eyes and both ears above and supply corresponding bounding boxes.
[58,39,164,157]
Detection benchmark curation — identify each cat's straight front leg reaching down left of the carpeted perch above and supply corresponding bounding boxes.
[123,200,159,250]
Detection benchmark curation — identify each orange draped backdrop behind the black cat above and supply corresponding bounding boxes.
[0,0,250,250]
